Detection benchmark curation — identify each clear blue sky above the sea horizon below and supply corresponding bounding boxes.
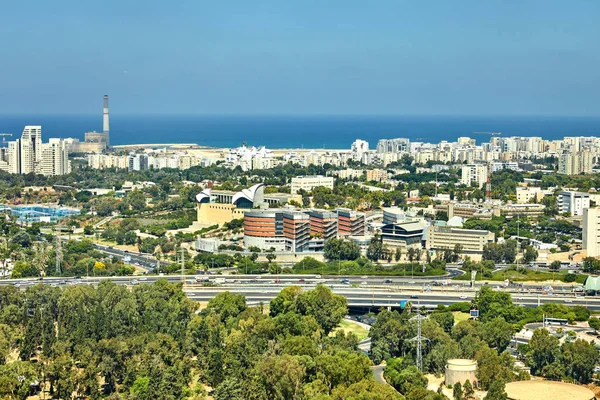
[0,0,600,116]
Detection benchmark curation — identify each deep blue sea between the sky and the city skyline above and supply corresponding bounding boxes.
[0,114,600,149]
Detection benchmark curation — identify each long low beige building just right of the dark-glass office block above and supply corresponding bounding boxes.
[425,226,495,253]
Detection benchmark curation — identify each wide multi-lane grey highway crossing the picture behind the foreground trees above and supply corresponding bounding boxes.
[0,275,600,311]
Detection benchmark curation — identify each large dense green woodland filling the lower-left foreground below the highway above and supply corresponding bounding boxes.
[0,280,400,400]
